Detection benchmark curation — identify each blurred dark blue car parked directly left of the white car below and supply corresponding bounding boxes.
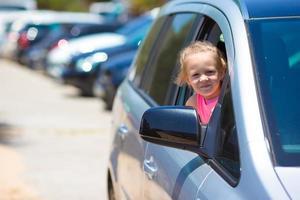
[18,22,122,69]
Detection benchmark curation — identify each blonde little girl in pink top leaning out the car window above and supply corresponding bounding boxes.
[176,41,226,124]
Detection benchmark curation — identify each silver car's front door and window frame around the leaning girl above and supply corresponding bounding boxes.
[143,4,240,199]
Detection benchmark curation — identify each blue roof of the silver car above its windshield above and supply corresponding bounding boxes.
[233,0,300,19]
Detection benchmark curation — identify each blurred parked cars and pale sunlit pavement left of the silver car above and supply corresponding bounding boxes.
[0,0,165,200]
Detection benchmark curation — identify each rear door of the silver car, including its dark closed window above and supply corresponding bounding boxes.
[114,13,201,199]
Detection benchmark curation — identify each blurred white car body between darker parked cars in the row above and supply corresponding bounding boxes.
[46,12,155,79]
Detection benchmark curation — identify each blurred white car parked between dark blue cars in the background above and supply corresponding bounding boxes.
[46,8,159,79]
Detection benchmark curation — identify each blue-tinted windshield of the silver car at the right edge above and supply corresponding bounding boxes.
[248,18,300,166]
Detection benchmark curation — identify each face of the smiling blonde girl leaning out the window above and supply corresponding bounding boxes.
[185,52,224,99]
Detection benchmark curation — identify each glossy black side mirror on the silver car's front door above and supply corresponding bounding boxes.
[140,106,207,157]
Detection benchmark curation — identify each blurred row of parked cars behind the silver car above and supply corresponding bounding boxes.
[0,0,165,110]
